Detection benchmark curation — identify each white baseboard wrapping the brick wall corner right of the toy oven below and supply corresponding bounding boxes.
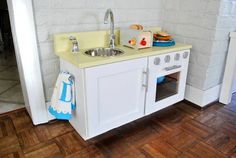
[185,85,221,107]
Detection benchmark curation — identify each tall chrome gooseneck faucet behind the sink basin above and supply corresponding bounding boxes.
[104,9,116,48]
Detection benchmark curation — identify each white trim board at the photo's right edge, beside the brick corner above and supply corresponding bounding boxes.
[219,32,236,104]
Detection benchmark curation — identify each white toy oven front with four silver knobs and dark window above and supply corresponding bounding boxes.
[145,51,188,115]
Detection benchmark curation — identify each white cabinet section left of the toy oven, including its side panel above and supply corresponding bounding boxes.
[61,58,147,139]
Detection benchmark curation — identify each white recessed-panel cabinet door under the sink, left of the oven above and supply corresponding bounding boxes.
[85,58,147,137]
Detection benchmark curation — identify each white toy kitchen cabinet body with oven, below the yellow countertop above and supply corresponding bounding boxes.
[60,50,190,140]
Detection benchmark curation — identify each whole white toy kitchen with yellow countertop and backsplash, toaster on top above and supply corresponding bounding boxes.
[54,12,192,140]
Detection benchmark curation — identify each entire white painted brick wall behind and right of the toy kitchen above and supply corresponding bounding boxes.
[33,0,236,100]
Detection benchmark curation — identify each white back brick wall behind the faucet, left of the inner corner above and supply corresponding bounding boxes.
[33,0,163,101]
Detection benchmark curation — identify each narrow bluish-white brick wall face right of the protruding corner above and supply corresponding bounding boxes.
[205,0,236,88]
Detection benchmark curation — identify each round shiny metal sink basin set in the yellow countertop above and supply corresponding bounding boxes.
[84,48,124,57]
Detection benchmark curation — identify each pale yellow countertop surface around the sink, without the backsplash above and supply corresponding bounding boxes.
[55,43,192,68]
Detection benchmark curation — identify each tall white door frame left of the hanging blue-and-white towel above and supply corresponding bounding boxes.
[7,0,48,125]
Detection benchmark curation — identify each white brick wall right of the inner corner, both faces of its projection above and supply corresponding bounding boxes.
[162,0,236,90]
